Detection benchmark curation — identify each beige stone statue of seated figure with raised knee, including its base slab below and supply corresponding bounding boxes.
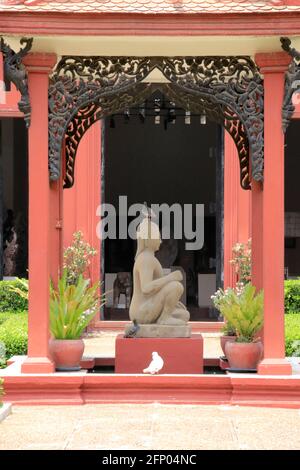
[125,210,190,337]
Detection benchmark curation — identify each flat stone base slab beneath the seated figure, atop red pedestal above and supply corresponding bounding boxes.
[125,323,191,338]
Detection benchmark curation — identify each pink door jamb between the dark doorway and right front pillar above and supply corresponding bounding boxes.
[224,132,250,288]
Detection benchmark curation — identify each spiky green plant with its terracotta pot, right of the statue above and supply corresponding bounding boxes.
[219,283,263,370]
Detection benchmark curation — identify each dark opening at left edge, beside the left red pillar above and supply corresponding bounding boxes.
[0,118,28,278]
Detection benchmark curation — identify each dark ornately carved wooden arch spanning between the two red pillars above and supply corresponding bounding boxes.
[49,57,263,189]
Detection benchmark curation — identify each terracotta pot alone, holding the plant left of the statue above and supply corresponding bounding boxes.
[49,339,84,371]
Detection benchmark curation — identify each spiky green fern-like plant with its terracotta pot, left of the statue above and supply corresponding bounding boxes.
[50,269,105,371]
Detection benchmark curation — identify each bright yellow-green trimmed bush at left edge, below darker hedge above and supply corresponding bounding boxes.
[0,312,28,359]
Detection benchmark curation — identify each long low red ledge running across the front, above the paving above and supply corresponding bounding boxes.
[5,370,300,409]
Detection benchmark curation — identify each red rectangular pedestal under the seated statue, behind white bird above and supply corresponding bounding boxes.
[115,335,203,374]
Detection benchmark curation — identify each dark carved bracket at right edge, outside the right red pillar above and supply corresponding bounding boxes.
[280,37,300,132]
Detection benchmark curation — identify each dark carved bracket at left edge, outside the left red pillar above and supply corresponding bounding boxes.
[0,37,33,128]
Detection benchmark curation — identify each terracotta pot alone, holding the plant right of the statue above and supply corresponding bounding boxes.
[225,341,263,370]
